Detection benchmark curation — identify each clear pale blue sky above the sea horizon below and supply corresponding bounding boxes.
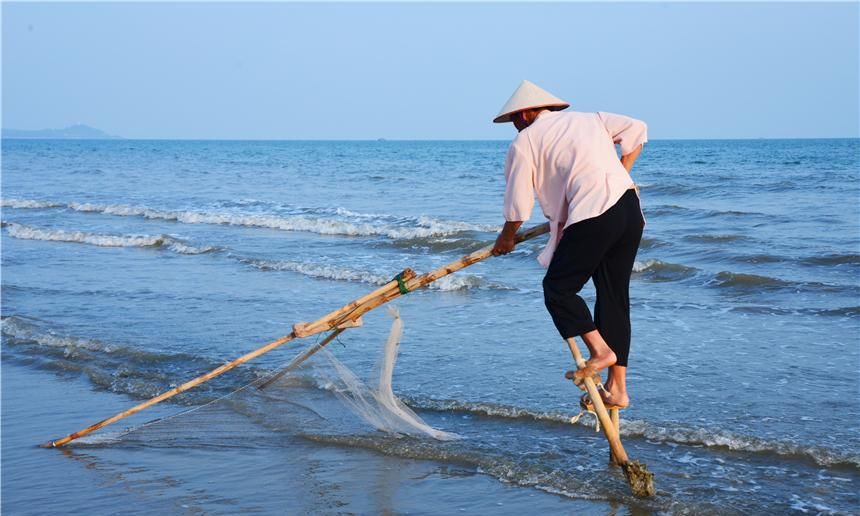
[2,2,860,139]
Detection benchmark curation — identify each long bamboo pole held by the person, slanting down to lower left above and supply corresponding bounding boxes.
[41,223,549,448]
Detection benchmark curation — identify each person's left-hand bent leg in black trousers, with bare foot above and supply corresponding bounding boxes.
[543,209,624,370]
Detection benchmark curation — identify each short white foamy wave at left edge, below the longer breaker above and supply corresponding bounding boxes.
[2,222,218,254]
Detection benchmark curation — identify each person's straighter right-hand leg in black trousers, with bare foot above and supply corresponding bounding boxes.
[592,192,643,406]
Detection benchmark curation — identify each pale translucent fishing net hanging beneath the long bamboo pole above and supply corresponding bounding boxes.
[78,307,459,446]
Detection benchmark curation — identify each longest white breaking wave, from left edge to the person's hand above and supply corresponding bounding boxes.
[2,199,498,240]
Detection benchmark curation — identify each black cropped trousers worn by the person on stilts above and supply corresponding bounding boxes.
[543,189,645,366]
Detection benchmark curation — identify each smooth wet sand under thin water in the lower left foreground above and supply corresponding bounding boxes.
[2,360,626,514]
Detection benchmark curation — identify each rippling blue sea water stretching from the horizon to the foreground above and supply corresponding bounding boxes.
[5,139,860,514]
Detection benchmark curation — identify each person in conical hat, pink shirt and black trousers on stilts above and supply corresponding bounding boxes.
[493,81,648,408]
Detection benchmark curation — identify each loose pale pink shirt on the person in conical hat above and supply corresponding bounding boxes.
[504,111,648,267]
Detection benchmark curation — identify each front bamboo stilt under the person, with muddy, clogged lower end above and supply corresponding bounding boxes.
[567,337,657,497]
